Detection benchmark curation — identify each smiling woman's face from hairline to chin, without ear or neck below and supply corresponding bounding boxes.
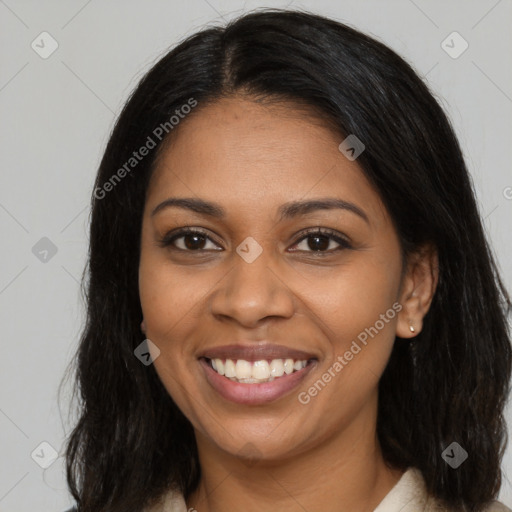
[139,98,416,460]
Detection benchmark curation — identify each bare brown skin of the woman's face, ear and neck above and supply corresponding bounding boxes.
[139,97,437,512]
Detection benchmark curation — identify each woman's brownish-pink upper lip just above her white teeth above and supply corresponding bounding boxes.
[199,343,315,361]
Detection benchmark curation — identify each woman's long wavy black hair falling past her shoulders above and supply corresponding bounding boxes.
[61,9,512,512]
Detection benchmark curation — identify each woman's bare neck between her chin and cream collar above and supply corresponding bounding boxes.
[187,402,403,512]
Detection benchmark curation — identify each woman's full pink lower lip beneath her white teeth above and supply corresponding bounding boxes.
[199,359,316,405]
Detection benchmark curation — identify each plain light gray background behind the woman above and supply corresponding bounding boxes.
[0,0,512,512]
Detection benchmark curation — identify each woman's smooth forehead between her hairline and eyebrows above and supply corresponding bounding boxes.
[148,98,385,226]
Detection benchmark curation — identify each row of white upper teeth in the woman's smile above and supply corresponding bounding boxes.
[211,359,307,384]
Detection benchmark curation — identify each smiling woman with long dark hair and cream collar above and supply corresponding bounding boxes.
[63,10,511,512]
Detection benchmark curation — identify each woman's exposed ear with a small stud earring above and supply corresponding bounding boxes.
[396,244,439,338]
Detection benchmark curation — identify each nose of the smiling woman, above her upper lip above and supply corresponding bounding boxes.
[211,250,295,328]
